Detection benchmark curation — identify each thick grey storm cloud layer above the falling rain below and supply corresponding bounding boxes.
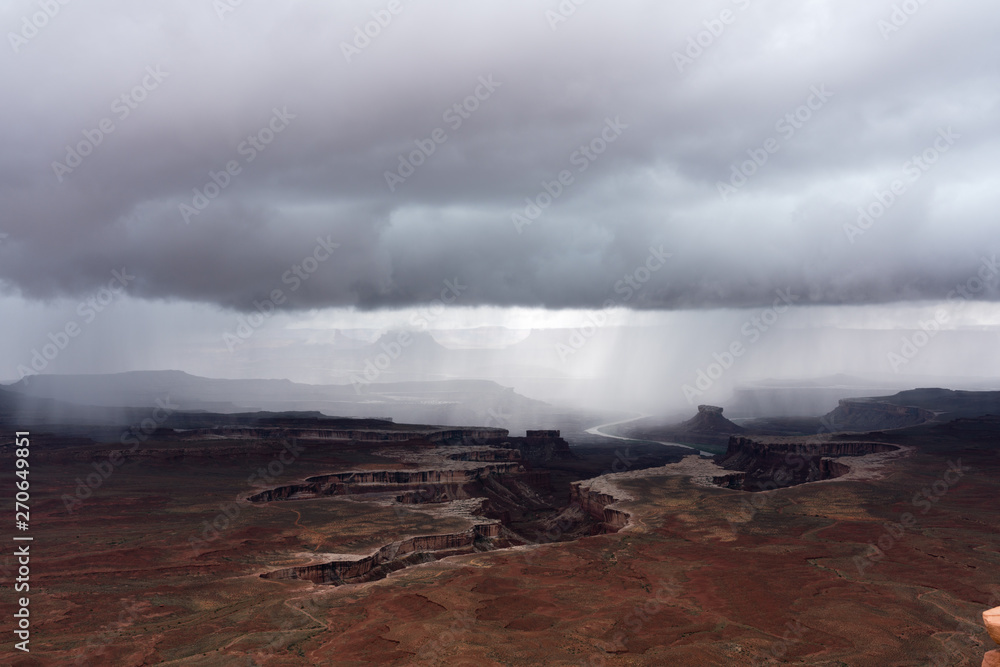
[0,0,1000,388]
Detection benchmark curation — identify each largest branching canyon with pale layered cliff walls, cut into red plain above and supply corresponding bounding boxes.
[247,430,629,585]
